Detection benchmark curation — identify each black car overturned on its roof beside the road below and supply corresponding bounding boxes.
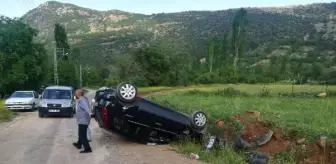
[92,83,207,142]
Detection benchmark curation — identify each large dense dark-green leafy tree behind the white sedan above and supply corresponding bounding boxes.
[0,16,47,95]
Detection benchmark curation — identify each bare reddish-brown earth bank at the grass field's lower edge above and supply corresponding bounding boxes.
[230,112,336,164]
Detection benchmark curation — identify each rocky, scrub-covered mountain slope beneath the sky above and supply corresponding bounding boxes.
[22,1,336,67]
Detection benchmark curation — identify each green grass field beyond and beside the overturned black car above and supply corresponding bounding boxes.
[143,84,336,164]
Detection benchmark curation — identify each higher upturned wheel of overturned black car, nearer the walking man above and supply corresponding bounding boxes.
[116,83,138,103]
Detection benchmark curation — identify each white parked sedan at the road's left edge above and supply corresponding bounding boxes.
[5,91,39,111]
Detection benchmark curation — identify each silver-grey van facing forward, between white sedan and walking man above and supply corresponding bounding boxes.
[38,86,76,118]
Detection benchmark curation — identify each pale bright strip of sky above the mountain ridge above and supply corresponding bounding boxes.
[0,0,332,17]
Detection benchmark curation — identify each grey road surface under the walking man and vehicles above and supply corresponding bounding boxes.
[0,91,200,164]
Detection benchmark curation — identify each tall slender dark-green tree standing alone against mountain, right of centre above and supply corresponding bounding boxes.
[231,8,247,69]
